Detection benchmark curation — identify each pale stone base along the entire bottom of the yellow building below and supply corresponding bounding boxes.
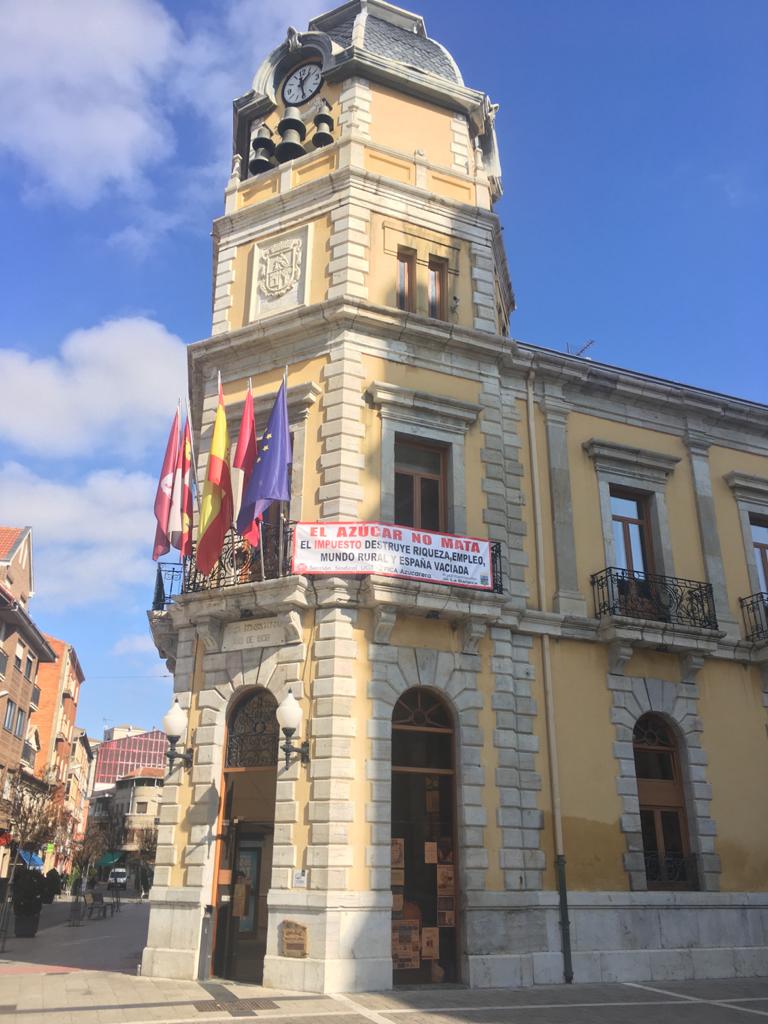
[142,890,768,992]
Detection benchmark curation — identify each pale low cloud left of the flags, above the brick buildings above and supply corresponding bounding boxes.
[0,462,157,614]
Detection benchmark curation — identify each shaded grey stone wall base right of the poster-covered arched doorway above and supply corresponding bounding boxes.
[466,892,768,988]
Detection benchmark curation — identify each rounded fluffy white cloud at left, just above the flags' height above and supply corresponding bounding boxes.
[0,316,186,457]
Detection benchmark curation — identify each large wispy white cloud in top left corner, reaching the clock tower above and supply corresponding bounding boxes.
[0,0,318,209]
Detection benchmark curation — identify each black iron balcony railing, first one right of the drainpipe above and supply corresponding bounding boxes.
[592,567,718,630]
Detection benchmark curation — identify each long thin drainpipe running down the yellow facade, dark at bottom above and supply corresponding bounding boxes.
[525,370,573,984]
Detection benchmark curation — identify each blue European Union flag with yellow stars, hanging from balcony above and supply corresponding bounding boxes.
[238,380,291,537]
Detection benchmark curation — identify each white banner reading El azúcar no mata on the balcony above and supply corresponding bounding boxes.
[293,522,494,590]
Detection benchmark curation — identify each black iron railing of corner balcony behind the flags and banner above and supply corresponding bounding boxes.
[152,523,504,611]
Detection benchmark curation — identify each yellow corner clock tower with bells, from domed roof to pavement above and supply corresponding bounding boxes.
[143,0,518,991]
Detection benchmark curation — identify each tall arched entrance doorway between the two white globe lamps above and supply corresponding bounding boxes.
[213,688,280,984]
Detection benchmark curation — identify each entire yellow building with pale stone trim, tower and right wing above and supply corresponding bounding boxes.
[144,0,768,991]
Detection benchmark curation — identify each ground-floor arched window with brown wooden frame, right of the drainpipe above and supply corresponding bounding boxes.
[633,715,697,889]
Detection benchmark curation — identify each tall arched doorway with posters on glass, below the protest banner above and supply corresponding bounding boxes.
[392,687,458,985]
